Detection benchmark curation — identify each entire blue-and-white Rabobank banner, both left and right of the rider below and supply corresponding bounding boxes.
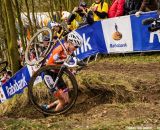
[0,12,160,102]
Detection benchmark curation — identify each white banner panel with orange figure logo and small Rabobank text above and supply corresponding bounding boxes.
[101,16,133,53]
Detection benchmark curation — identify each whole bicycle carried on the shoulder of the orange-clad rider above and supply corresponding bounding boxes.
[26,28,85,115]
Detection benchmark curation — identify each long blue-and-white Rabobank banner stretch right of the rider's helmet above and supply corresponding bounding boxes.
[76,11,160,59]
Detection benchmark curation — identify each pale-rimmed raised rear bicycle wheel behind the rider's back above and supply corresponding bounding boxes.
[25,27,52,66]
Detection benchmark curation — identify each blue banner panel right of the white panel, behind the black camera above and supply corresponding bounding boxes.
[131,12,160,51]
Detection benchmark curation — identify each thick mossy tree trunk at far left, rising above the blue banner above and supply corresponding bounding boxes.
[4,0,20,74]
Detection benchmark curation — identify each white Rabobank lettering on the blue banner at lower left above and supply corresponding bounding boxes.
[6,74,27,96]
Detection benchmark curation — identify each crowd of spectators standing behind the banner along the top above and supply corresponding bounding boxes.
[14,0,160,75]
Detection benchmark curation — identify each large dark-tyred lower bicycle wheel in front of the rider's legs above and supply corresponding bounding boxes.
[28,66,78,115]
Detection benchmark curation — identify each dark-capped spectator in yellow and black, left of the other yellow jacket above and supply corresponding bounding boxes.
[67,2,94,26]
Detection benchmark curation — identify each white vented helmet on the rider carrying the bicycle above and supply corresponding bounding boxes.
[67,31,83,47]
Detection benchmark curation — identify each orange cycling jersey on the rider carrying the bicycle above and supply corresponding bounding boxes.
[47,45,67,65]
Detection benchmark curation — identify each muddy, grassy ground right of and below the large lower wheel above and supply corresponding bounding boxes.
[0,55,160,130]
